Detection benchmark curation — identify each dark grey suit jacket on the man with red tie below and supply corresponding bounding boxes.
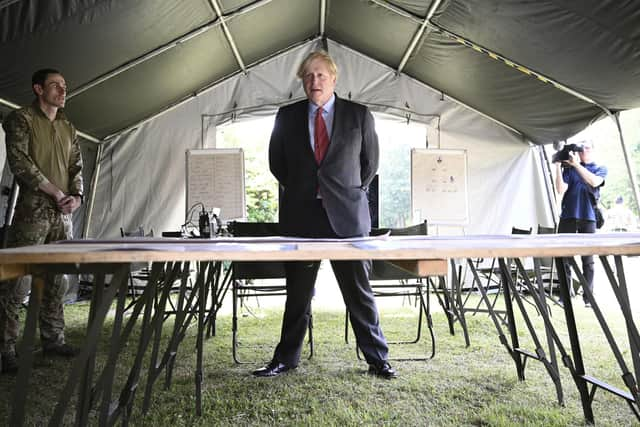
[269,96,379,237]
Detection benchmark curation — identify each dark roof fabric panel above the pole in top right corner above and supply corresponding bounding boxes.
[434,0,640,110]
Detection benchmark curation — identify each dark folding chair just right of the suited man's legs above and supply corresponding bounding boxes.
[345,221,435,360]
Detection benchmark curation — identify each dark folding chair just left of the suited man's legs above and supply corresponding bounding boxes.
[228,221,313,363]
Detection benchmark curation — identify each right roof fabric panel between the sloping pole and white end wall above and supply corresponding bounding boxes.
[406,29,602,144]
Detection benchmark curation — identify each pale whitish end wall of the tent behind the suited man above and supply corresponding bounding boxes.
[90,42,553,237]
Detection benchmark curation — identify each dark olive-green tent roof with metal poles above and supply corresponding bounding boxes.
[0,0,640,143]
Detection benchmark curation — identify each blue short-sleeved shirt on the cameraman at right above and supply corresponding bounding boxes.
[560,163,607,221]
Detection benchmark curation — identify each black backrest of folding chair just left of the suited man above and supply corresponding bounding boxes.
[227,221,285,280]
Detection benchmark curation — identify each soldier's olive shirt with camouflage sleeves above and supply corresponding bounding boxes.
[2,102,83,201]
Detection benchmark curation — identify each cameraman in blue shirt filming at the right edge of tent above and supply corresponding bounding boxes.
[556,140,607,307]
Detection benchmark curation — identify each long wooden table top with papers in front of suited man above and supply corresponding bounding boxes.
[0,233,640,264]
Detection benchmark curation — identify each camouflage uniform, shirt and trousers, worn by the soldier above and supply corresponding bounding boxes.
[0,103,82,353]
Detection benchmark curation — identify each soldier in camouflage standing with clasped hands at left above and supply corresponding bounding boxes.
[0,69,83,373]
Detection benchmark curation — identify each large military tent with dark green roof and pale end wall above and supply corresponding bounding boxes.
[0,0,640,237]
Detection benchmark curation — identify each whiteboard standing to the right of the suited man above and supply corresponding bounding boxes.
[411,148,469,225]
